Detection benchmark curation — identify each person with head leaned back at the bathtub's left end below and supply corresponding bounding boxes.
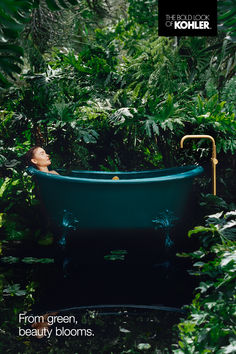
[26,146,59,175]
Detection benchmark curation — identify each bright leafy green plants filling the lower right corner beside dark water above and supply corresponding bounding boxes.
[174,211,236,354]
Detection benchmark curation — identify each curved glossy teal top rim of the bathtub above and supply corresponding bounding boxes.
[27,165,204,185]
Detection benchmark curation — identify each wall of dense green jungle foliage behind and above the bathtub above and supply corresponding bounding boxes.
[1,1,236,173]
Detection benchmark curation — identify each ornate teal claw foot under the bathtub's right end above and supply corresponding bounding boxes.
[152,209,178,248]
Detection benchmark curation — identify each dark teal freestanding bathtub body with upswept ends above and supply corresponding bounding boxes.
[28,166,203,230]
